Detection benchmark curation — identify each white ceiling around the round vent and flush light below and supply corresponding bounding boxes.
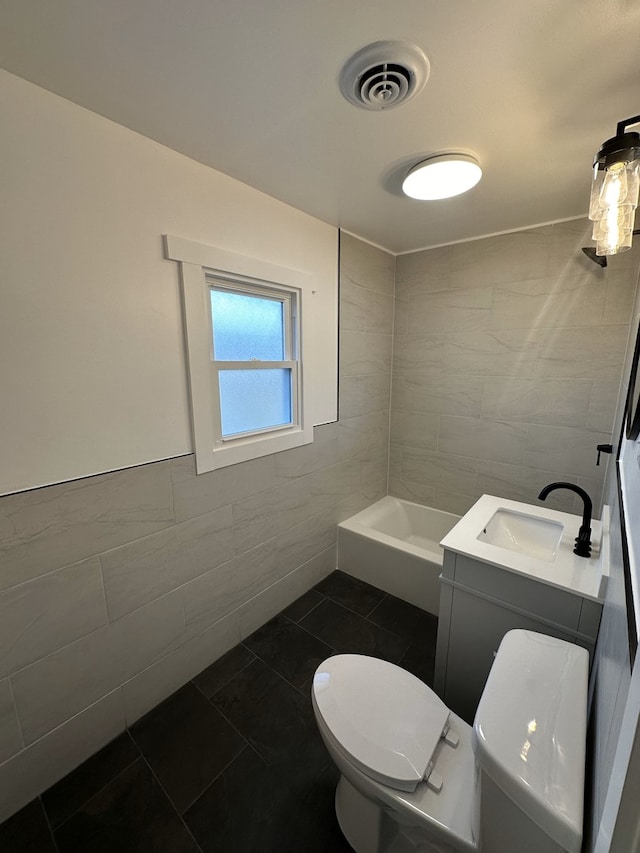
[0,0,640,253]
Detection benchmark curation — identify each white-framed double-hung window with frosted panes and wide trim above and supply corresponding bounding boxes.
[166,237,313,473]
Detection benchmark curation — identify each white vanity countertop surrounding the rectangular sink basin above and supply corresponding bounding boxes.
[440,495,609,602]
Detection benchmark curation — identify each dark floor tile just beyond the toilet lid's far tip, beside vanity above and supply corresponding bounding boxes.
[300,601,409,663]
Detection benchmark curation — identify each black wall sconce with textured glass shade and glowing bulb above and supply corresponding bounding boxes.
[589,116,640,255]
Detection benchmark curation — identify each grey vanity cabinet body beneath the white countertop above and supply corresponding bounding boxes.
[434,551,602,723]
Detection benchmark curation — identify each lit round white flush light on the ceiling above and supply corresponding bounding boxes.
[402,154,482,201]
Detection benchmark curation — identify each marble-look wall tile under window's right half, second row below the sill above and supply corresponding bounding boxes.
[232,474,315,554]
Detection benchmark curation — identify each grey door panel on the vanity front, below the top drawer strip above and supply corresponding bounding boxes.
[443,589,574,723]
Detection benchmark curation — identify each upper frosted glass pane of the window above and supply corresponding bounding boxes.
[211,290,285,361]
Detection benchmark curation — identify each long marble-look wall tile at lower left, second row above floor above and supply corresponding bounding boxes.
[11,593,184,744]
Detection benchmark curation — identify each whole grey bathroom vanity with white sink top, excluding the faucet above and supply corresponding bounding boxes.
[434,495,608,722]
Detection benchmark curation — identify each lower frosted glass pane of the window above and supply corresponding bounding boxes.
[218,368,292,436]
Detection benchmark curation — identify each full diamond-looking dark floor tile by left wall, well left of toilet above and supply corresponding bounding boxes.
[131,684,246,814]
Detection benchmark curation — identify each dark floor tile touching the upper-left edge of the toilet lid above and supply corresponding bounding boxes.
[244,616,334,687]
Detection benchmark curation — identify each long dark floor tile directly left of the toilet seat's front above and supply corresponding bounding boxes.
[213,660,334,801]
